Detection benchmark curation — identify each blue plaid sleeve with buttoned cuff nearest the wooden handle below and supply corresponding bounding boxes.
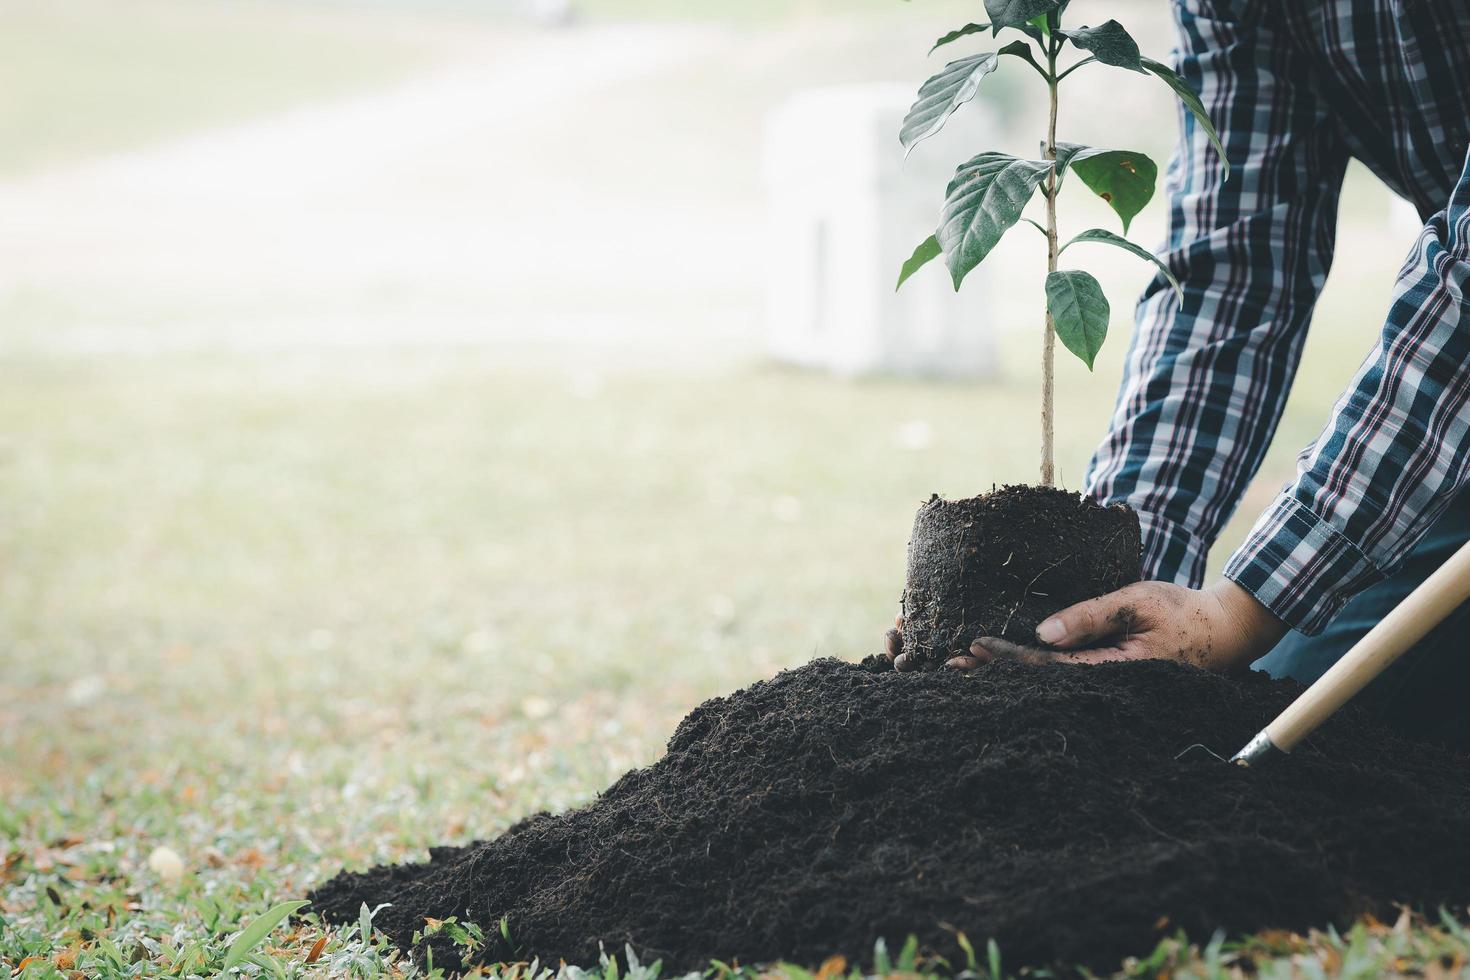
[1225,149,1470,633]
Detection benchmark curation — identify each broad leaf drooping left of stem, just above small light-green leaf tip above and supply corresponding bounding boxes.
[938,153,1051,289]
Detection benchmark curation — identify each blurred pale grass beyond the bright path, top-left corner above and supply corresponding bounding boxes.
[0,0,476,176]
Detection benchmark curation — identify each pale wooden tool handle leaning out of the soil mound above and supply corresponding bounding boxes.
[1266,544,1470,752]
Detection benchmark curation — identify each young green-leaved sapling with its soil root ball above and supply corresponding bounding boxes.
[895,0,1225,670]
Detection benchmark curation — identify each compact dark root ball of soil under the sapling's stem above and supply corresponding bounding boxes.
[903,486,1139,670]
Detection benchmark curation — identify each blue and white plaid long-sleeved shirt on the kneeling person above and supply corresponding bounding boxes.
[1086,0,1470,633]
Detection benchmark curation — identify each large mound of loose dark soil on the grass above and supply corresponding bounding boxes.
[310,660,1470,970]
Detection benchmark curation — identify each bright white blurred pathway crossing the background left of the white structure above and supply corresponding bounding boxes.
[0,25,760,359]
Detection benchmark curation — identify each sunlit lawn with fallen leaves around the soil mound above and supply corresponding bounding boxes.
[0,353,1467,980]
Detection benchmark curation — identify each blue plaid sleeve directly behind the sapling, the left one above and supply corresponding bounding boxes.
[1085,0,1348,586]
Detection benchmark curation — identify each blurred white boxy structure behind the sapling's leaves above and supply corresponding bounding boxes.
[764,85,995,378]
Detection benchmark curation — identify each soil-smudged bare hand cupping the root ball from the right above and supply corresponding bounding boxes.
[946,579,1288,673]
